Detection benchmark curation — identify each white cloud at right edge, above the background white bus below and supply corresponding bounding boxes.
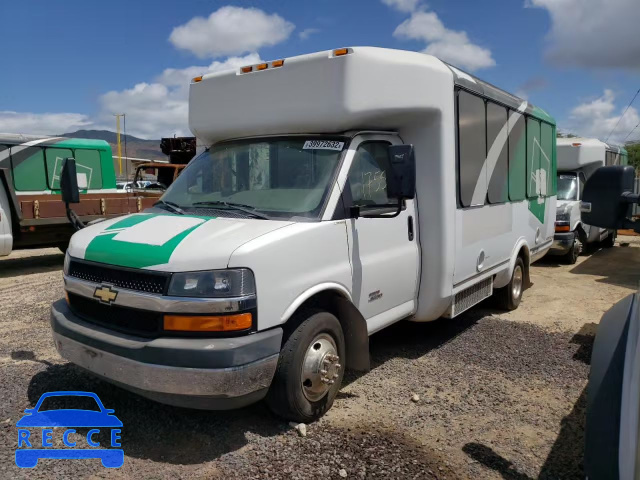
[562,89,640,143]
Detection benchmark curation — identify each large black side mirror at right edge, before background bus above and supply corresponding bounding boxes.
[581,165,635,229]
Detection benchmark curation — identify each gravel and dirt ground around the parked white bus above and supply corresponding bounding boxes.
[0,237,640,479]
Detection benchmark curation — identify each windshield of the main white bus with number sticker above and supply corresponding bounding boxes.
[162,136,347,219]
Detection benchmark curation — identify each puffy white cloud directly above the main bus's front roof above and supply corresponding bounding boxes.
[169,6,295,58]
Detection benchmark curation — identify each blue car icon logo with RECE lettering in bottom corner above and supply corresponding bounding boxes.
[15,391,124,468]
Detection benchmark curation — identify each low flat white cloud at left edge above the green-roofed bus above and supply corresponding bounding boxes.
[0,111,92,135]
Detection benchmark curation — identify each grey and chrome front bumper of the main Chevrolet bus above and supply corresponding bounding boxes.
[51,300,282,409]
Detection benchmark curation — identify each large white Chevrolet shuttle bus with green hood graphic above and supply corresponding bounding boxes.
[51,47,556,421]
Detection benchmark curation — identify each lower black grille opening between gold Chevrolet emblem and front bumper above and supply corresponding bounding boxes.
[68,293,163,337]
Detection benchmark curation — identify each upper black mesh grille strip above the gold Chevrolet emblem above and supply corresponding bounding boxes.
[69,260,171,295]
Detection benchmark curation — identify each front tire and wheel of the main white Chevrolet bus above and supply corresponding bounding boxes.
[266,310,346,423]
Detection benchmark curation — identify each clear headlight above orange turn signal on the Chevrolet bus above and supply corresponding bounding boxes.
[168,268,256,298]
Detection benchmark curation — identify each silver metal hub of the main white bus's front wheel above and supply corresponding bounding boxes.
[300,333,342,402]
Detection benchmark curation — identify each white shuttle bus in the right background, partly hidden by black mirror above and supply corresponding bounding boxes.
[549,137,628,265]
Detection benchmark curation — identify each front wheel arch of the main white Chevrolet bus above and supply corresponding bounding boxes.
[282,283,370,371]
